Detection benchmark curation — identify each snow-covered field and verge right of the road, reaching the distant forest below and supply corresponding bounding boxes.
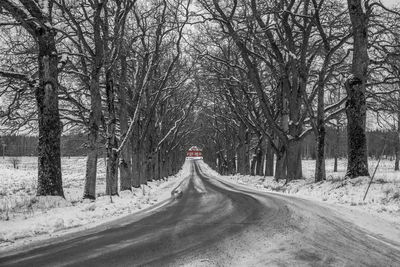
[203,159,400,222]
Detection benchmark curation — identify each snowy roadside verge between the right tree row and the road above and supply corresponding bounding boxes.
[200,162,400,244]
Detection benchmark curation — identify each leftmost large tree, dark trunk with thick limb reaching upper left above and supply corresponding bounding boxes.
[0,0,64,196]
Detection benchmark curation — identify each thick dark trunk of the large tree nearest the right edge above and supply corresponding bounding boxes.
[345,0,369,178]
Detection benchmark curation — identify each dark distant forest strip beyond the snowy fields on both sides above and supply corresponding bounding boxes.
[0,128,397,159]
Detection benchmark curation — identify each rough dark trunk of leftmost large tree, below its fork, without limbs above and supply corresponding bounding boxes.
[36,29,64,197]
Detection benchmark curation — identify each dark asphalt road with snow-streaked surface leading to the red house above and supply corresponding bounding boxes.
[0,161,400,266]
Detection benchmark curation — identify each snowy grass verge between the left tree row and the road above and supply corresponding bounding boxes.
[0,158,190,250]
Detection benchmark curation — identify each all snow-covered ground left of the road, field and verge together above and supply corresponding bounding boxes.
[0,157,190,249]
